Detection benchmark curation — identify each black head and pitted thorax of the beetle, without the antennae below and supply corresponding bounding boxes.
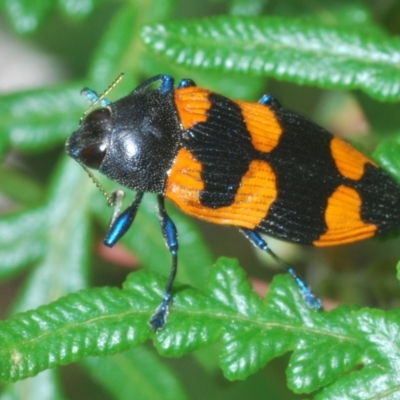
[66,90,181,193]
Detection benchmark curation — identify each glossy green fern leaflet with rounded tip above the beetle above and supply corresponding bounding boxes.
[142,16,400,101]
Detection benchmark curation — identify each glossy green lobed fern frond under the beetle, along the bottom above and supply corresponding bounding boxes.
[0,259,400,399]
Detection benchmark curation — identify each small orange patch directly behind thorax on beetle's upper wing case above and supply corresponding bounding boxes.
[175,86,211,129]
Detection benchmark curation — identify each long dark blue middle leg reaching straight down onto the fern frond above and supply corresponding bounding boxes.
[150,195,178,330]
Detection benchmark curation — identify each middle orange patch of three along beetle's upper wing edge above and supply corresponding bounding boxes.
[236,101,283,153]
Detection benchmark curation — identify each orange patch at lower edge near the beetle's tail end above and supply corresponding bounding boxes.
[313,185,377,246]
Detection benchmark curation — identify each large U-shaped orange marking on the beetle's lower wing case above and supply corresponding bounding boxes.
[165,148,277,229]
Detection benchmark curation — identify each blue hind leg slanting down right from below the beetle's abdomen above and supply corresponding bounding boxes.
[241,229,322,310]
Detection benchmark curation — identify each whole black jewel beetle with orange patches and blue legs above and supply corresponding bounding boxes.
[66,74,400,330]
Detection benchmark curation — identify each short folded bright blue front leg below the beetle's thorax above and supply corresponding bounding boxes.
[104,192,143,247]
